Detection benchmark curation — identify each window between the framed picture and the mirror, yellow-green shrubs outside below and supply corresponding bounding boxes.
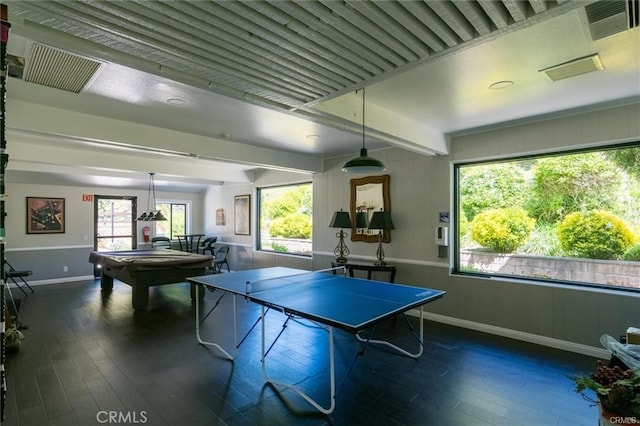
[258,183,313,256]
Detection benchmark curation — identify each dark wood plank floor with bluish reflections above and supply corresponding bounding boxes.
[3,281,597,426]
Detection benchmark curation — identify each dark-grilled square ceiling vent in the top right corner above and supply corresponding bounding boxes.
[584,0,640,40]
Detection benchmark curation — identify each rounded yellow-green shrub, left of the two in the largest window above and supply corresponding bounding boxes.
[470,207,536,253]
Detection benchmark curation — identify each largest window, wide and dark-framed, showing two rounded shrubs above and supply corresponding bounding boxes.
[454,144,640,291]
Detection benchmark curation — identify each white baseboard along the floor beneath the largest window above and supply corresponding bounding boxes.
[409,309,611,359]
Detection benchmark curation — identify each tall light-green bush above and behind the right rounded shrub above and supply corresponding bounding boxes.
[526,152,620,223]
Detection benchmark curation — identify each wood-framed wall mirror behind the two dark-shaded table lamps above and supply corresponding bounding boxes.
[349,175,391,243]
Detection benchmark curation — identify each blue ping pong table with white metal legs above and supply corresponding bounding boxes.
[187,267,445,414]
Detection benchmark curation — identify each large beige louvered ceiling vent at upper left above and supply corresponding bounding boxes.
[24,43,100,93]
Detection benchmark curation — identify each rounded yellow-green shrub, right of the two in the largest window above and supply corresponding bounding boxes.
[558,210,633,260]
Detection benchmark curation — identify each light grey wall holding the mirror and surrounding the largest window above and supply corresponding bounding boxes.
[313,104,640,353]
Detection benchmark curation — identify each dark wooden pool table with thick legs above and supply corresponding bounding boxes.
[89,249,213,310]
